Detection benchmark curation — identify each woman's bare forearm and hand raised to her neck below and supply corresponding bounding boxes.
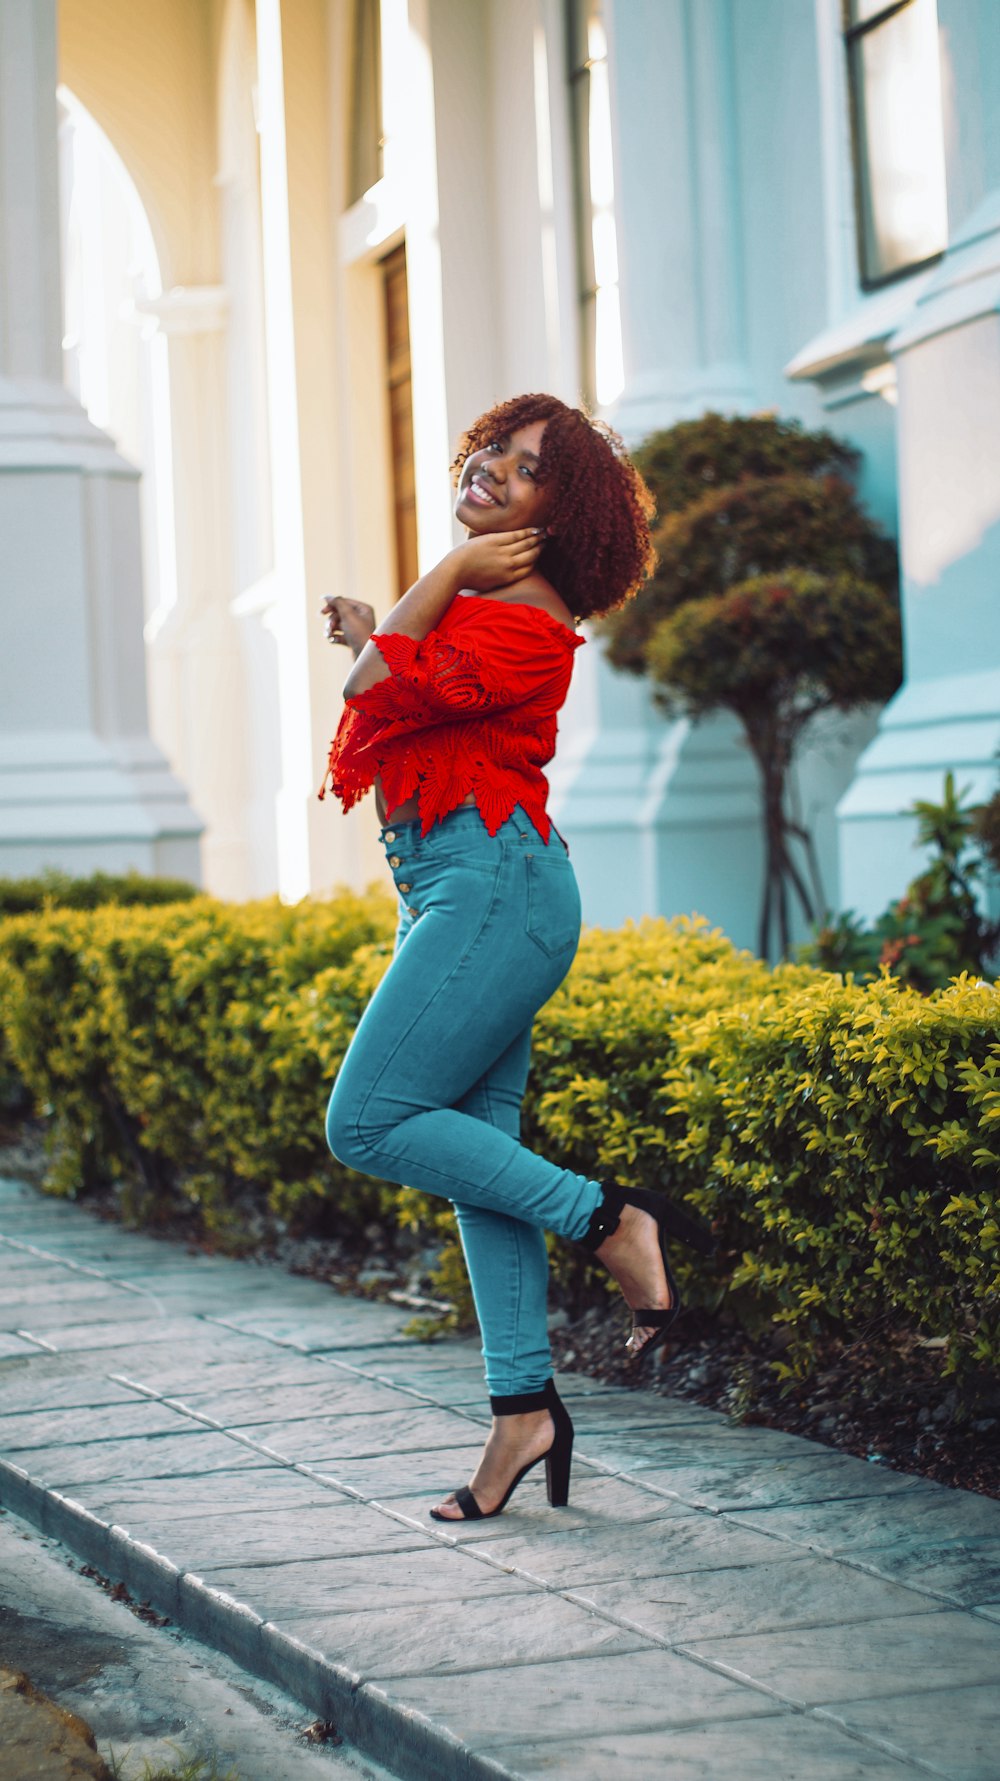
[344,527,545,698]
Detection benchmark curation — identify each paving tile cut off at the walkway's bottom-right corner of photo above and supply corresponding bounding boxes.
[816,1676,1000,1781]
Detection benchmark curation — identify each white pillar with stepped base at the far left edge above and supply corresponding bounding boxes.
[0,0,201,878]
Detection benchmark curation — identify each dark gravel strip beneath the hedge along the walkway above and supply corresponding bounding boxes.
[0,1122,1000,1498]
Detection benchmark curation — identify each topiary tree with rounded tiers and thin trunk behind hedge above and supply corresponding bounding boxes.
[597,413,902,956]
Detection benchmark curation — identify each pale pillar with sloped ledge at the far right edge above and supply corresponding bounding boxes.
[840,0,1000,915]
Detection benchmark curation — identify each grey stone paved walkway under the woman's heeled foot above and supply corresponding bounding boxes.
[0,1181,1000,1781]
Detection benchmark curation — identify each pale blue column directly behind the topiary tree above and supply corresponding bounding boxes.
[551,0,763,946]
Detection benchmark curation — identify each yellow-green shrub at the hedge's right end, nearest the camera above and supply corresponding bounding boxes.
[665,972,1000,1373]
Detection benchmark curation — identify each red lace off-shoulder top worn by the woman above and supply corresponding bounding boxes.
[319,593,586,842]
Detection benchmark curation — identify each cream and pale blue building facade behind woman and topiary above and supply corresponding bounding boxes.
[0,0,1000,944]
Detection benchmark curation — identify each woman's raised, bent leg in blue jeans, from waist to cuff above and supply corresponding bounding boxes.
[326,812,602,1238]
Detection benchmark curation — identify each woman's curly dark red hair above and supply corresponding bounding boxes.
[451,394,656,618]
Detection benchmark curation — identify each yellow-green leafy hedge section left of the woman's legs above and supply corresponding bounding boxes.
[0,892,392,1238]
